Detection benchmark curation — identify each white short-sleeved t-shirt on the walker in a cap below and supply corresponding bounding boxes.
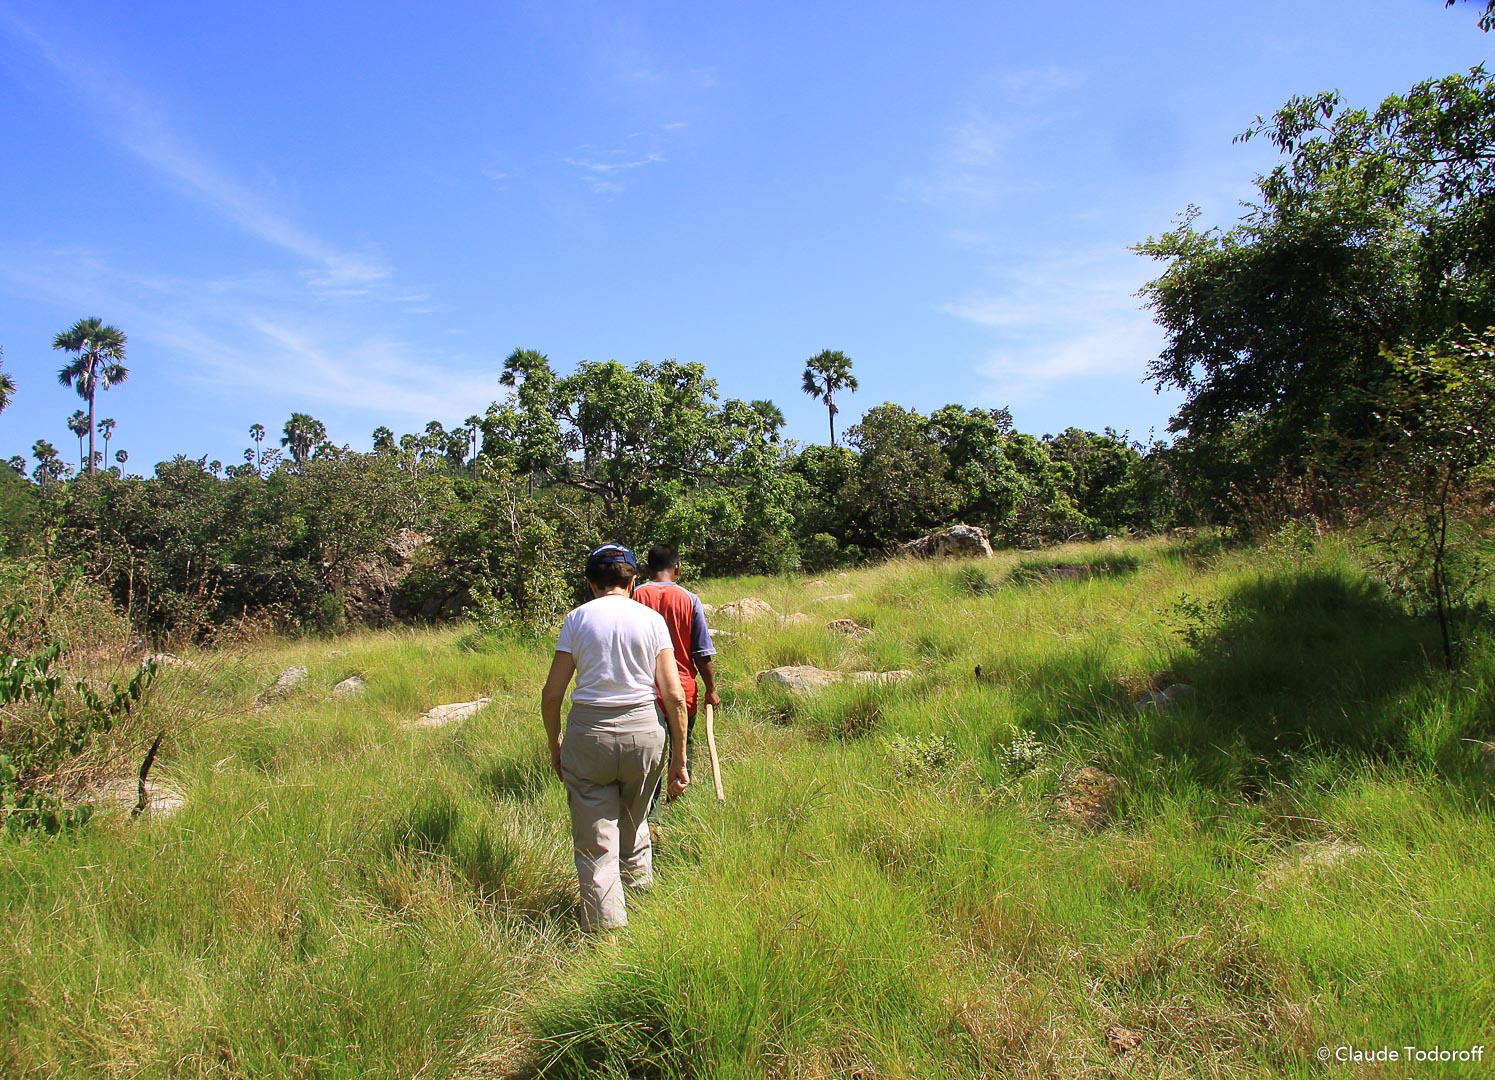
[556,594,674,706]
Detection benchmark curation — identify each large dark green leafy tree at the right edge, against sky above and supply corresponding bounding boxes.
[1139,69,1495,515]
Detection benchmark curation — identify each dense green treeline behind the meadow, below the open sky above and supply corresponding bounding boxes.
[0,350,1193,636]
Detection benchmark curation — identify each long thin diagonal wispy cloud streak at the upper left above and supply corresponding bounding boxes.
[0,10,390,298]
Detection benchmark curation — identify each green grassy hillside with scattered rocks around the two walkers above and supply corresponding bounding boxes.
[0,541,1495,1077]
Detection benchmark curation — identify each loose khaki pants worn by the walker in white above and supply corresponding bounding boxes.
[561,702,665,930]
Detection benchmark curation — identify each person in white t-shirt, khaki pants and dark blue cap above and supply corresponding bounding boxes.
[540,544,691,932]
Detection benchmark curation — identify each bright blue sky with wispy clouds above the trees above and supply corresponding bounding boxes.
[0,0,1495,471]
